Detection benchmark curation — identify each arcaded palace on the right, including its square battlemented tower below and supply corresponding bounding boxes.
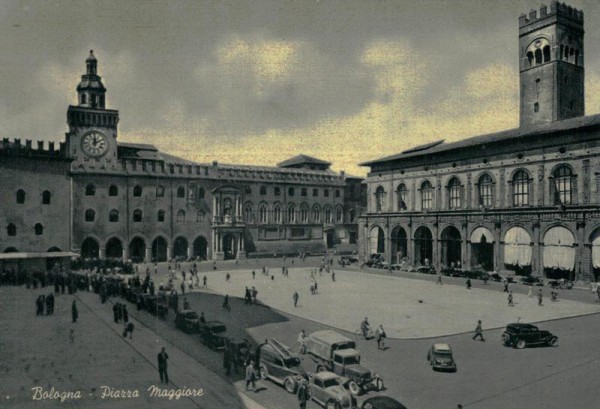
[359,1,600,280]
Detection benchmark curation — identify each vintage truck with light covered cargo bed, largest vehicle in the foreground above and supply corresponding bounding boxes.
[306,330,383,395]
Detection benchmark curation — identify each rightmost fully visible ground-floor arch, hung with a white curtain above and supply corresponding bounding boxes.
[542,226,575,280]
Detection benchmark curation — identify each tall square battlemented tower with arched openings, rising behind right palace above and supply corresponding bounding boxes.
[519,1,585,126]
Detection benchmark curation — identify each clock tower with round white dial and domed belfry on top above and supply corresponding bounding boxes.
[66,50,119,164]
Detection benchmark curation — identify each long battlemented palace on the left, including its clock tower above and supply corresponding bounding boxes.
[0,52,366,267]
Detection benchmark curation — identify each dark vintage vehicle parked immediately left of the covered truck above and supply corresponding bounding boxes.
[255,338,308,393]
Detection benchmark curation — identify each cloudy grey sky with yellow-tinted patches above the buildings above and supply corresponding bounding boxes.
[0,0,600,176]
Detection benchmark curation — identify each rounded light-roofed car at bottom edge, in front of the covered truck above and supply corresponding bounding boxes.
[308,371,356,409]
